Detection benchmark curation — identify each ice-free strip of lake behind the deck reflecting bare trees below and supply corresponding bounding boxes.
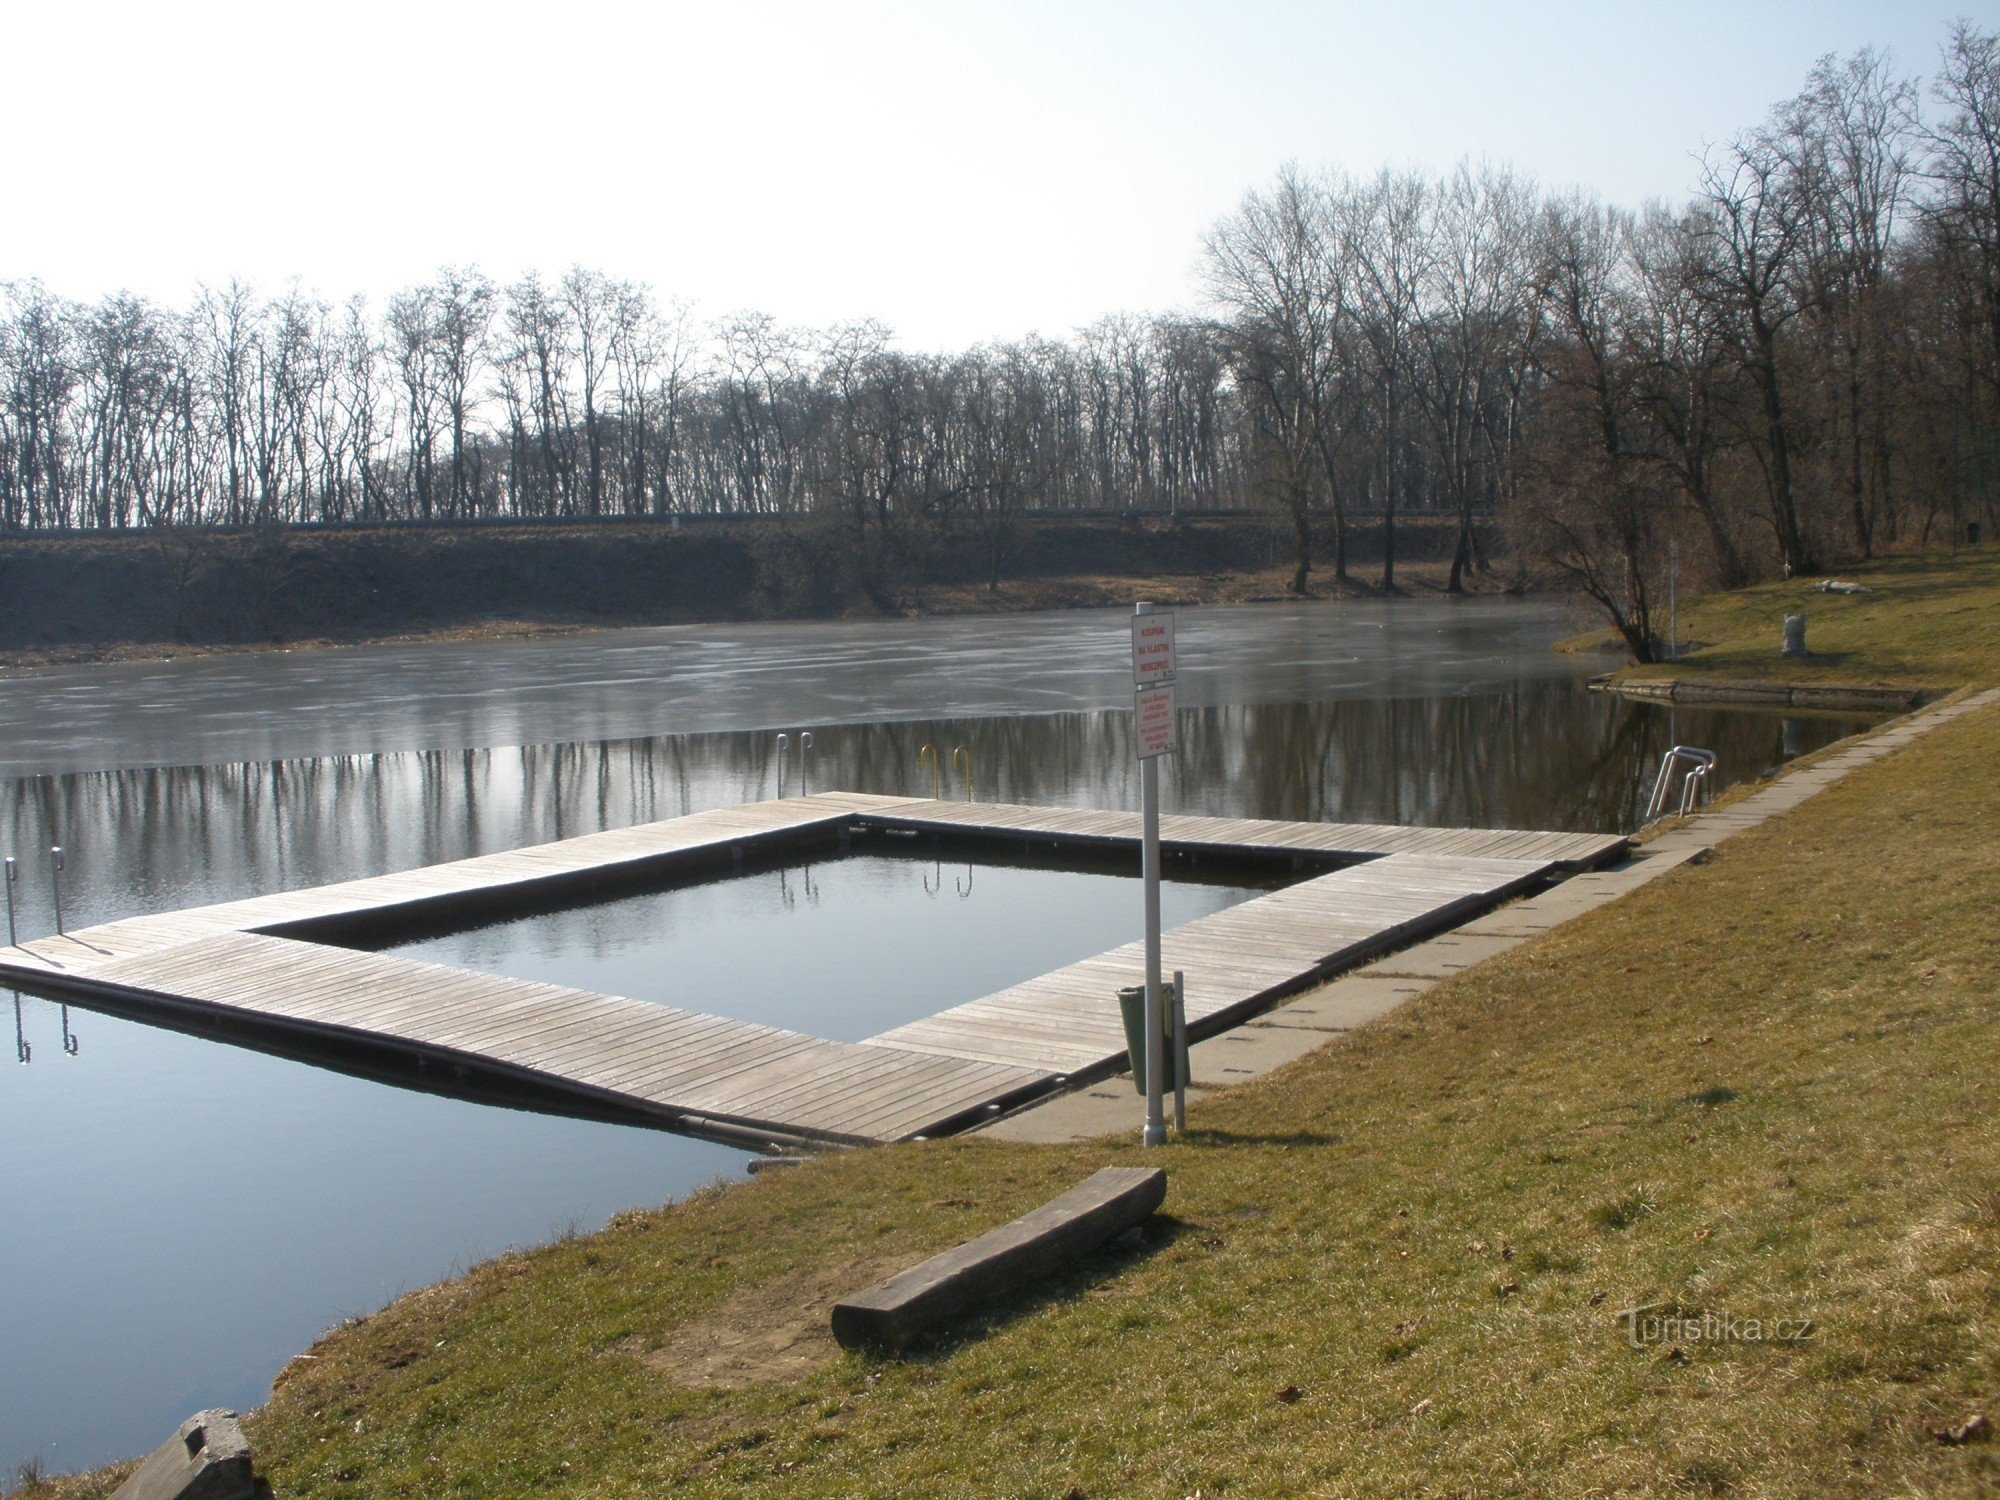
[0,682,1852,932]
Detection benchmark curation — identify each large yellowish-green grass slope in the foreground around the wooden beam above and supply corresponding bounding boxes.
[35,710,2000,1496]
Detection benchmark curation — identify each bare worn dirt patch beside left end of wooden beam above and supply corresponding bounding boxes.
[634,1258,904,1388]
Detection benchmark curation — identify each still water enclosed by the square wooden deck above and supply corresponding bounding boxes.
[368,848,1286,1042]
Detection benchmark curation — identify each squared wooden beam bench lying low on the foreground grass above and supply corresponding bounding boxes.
[834,1166,1166,1348]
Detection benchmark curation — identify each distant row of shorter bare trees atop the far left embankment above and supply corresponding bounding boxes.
[0,268,1244,544]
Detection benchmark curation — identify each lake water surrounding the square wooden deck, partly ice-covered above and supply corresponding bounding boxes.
[0,600,1864,1470]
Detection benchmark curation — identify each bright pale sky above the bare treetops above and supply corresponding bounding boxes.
[0,0,2000,348]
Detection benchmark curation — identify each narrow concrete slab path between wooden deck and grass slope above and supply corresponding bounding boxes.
[978,688,2000,1142]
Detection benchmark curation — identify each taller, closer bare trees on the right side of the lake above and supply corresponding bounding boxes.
[1208,24,2000,658]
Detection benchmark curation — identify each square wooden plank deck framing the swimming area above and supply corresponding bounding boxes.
[0,792,1626,1144]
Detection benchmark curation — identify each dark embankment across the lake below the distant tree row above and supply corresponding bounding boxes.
[0,516,1452,652]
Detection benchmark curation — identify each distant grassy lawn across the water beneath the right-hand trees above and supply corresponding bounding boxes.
[1564,546,2000,688]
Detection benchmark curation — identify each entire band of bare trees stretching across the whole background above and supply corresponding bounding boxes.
[0,24,2000,660]
